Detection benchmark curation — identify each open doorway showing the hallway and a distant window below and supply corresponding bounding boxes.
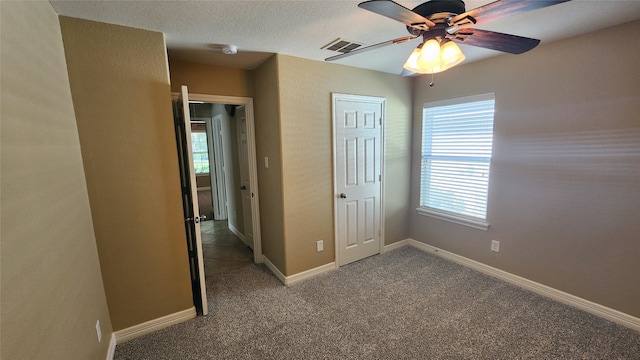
[189,102,255,277]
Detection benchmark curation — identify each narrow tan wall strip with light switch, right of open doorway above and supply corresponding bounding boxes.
[254,56,285,271]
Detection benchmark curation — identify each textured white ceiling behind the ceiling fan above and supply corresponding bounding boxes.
[51,0,640,74]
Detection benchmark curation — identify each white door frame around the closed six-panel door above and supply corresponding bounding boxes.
[331,93,387,268]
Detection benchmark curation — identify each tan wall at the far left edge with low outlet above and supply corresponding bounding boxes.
[0,1,112,360]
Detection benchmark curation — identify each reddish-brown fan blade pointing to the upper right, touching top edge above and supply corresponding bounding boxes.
[449,0,570,26]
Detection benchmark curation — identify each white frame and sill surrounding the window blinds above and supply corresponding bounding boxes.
[416,92,495,230]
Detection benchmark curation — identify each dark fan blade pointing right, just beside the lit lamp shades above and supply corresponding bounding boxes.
[451,28,540,54]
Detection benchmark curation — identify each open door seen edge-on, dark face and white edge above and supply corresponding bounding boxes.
[173,86,208,315]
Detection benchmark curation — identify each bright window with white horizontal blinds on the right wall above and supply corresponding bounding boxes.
[417,93,495,230]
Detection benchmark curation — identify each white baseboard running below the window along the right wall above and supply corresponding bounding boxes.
[396,239,640,331]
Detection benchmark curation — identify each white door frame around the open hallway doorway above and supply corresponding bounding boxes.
[174,93,264,264]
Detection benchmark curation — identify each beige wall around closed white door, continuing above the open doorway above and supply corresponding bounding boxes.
[170,55,411,275]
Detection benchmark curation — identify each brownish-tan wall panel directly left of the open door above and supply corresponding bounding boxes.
[60,17,193,330]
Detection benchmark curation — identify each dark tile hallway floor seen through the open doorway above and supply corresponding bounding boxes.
[200,220,253,277]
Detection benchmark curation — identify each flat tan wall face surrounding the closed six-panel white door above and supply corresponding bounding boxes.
[277,55,412,275]
